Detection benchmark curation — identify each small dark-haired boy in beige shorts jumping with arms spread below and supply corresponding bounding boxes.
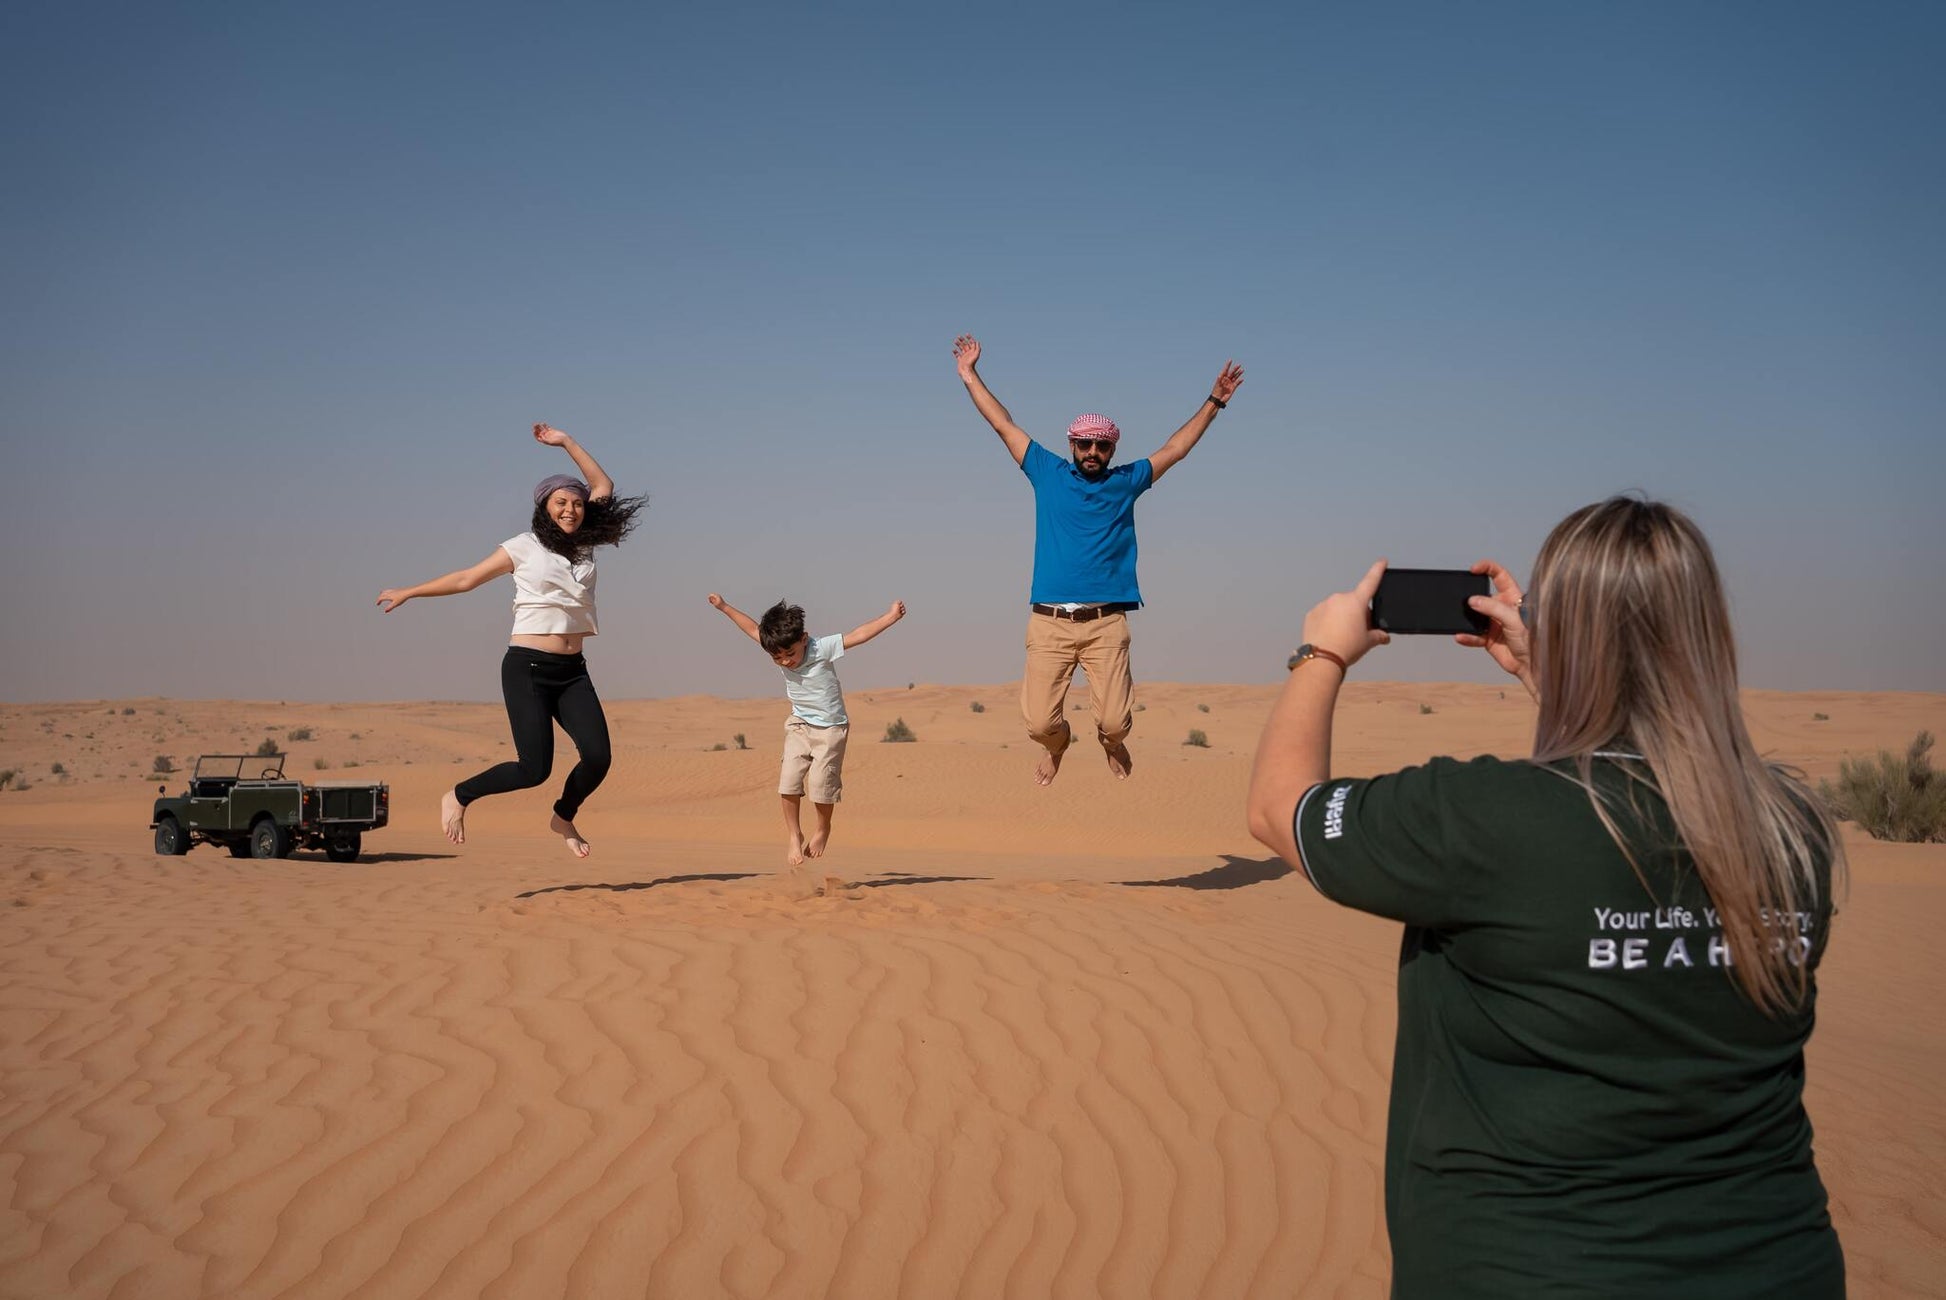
[710,592,905,866]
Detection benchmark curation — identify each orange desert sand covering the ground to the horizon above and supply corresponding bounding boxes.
[0,683,1946,1300]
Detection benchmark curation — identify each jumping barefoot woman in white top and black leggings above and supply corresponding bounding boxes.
[378,424,644,858]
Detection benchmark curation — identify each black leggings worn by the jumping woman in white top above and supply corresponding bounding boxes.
[453,646,611,821]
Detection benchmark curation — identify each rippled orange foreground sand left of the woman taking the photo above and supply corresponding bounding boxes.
[0,849,1391,1300]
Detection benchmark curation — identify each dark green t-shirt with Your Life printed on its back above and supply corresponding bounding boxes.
[1296,759,1845,1300]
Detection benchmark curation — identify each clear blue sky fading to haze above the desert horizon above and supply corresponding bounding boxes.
[0,2,1946,701]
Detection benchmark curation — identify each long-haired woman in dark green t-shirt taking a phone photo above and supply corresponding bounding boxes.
[1249,498,1845,1298]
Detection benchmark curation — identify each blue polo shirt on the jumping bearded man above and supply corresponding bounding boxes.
[1020,442,1156,605]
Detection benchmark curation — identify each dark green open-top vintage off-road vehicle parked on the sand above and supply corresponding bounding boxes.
[148,753,391,862]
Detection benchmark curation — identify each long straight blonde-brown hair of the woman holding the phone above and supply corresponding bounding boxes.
[1530,496,1845,1016]
